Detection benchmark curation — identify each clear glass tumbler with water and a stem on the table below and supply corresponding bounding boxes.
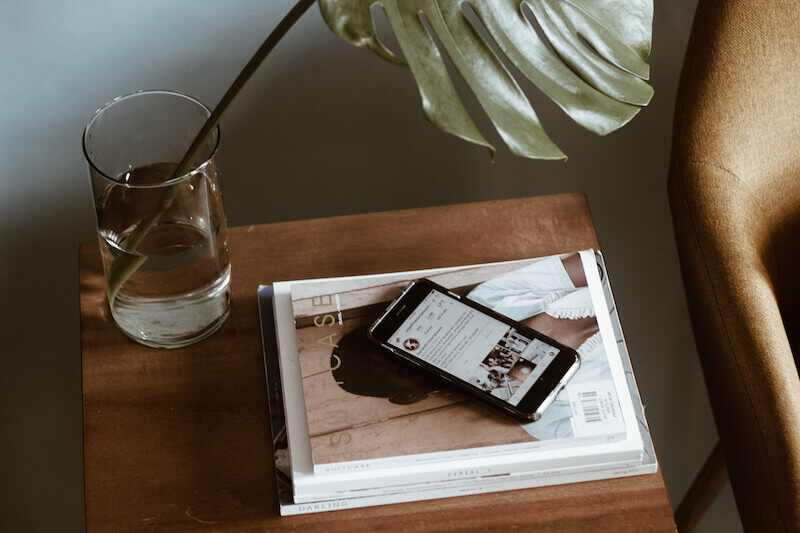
[83,91,231,348]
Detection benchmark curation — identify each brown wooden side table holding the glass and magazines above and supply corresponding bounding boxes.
[80,194,675,533]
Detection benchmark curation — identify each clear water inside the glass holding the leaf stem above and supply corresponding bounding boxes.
[97,160,230,348]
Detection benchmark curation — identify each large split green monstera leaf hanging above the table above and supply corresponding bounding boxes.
[319,0,653,159]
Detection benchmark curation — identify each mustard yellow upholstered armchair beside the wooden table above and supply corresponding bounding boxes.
[669,0,800,531]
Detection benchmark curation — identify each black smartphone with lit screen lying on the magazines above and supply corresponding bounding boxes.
[368,279,580,421]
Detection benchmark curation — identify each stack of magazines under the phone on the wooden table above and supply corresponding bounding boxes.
[258,250,658,515]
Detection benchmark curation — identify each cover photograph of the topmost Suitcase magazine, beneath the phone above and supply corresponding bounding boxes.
[291,253,624,465]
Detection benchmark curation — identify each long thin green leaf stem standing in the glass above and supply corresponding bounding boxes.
[106,0,316,306]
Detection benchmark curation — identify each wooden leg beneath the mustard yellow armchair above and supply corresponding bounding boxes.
[675,442,728,533]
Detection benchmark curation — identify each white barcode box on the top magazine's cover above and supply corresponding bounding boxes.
[567,380,625,437]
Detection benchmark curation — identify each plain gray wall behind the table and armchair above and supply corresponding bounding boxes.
[0,0,740,531]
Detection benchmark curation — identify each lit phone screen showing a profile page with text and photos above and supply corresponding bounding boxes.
[389,290,559,405]
